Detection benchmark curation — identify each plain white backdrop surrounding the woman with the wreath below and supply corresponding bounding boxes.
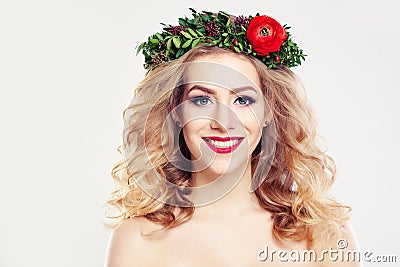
[0,0,400,267]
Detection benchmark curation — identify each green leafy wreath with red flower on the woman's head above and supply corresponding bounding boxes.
[136,8,306,69]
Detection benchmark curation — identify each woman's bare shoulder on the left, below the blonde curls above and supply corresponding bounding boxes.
[105,218,162,267]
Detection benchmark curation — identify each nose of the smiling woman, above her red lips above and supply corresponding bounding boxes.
[210,102,239,131]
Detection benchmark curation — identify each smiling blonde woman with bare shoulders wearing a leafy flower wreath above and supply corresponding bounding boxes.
[106,10,359,266]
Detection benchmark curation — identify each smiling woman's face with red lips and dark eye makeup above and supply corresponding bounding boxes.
[179,54,267,178]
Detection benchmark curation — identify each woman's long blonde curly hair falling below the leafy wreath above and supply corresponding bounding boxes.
[106,45,350,247]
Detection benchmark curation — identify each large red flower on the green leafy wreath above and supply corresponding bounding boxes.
[246,16,287,56]
